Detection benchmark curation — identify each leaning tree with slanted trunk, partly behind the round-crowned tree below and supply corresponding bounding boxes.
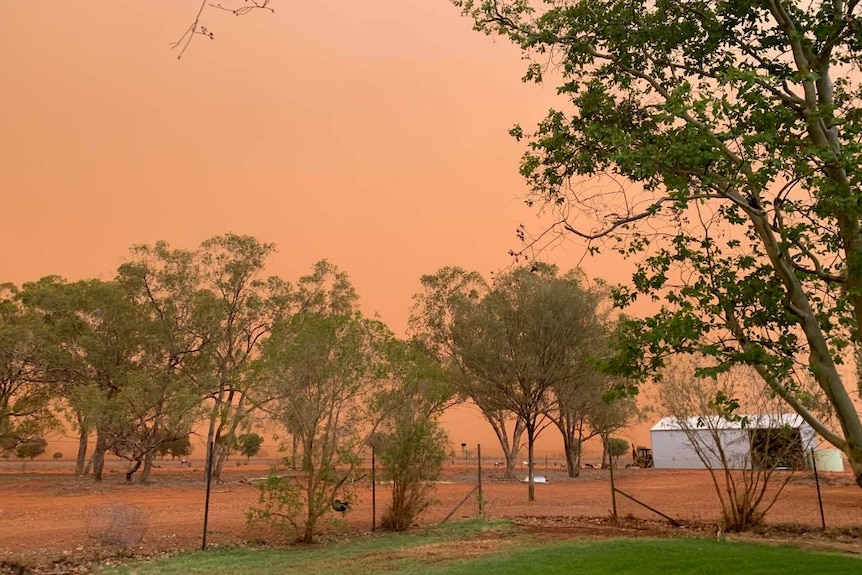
[409,267,524,478]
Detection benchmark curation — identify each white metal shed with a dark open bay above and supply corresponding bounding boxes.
[650,413,816,469]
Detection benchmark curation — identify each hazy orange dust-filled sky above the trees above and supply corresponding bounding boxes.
[0,0,640,460]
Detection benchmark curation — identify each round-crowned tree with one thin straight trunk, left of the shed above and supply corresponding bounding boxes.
[452,264,597,501]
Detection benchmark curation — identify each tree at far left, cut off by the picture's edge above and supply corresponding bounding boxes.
[0,284,57,453]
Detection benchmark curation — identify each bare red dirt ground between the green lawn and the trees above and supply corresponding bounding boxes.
[0,462,862,574]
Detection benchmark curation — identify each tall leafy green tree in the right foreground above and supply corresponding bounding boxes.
[462,0,862,487]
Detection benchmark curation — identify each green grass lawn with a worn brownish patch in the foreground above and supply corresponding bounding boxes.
[100,520,862,575]
